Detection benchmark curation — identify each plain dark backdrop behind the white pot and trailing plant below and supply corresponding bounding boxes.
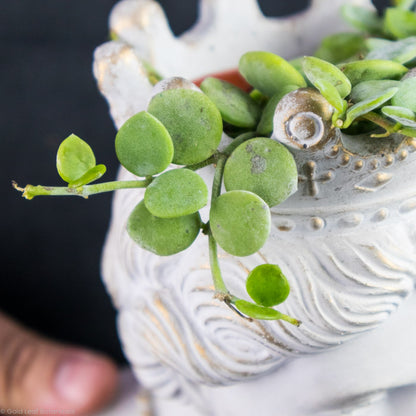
[0,0,387,362]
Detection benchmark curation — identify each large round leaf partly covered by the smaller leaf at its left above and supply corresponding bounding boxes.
[148,89,223,165]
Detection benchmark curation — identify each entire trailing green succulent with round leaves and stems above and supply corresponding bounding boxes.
[13,0,416,325]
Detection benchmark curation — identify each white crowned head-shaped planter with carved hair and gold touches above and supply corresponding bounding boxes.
[94,0,416,416]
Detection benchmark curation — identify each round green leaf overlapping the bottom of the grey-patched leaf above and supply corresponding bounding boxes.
[210,191,271,256]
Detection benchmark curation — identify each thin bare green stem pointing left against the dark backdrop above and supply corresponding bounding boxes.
[12,177,153,199]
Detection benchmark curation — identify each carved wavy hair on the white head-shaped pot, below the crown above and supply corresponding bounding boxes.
[103,172,416,406]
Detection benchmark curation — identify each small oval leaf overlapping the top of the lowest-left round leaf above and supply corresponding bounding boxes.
[144,169,208,218]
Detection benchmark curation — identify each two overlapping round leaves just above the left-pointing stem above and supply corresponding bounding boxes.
[115,89,222,176]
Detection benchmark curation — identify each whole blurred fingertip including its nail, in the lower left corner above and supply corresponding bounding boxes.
[0,313,117,415]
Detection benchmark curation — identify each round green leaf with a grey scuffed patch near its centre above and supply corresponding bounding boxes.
[224,137,298,207]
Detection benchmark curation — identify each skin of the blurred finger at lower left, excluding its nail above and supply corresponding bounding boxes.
[0,314,117,415]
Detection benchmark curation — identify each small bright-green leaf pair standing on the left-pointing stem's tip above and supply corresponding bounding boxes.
[56,134,106,187]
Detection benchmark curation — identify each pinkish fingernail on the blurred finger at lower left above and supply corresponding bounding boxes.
[55,353,102,406]
